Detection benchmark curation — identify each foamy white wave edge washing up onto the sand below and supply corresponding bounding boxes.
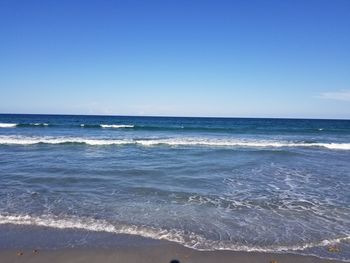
[0,214,350,252]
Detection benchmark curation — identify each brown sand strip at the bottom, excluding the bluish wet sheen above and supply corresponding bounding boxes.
[0,242,341,263]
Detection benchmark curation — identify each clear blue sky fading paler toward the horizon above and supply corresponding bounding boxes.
[0,0,350,119]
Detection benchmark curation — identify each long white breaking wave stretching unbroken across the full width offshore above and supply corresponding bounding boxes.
[0,136,350,150]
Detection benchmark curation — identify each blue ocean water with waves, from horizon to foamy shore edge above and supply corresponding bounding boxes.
[0,114,350,260]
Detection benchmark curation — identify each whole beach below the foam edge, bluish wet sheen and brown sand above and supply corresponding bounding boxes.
[0,224,349,263]
